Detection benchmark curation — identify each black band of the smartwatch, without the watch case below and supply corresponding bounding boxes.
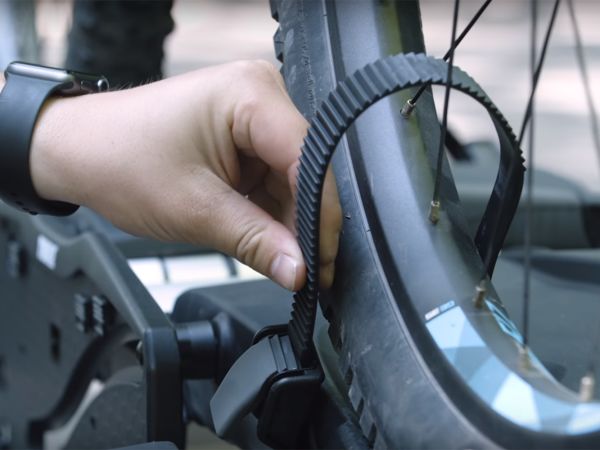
[0,72,78,216]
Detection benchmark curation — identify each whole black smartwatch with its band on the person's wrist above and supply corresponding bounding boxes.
[0,62,108,216]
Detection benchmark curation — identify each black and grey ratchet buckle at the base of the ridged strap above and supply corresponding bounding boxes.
[210,325,323,448]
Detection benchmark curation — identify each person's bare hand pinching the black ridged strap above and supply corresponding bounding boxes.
[30,62,341,290]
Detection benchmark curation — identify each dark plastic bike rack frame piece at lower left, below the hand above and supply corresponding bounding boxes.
[0,205,184,448]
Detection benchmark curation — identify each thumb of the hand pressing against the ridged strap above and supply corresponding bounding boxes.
[205,180,305,290]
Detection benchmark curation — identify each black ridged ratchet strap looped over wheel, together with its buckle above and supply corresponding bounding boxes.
[210,54,524,448]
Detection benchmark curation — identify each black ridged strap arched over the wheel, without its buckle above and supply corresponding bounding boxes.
[289,53,524,367]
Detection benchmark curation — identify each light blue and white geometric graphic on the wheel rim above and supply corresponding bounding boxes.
[426,299,600,435]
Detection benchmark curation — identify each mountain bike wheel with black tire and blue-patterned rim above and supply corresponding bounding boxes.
[271,0,600,448]
